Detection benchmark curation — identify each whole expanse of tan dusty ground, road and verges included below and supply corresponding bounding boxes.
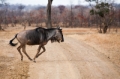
[0,27,120,79]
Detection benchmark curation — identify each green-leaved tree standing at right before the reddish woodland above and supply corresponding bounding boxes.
[86,0,113,33]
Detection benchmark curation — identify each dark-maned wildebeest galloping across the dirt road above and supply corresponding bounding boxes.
[9,27,64,62]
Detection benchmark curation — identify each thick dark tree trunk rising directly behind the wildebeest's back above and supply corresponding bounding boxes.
[46,0,53,28]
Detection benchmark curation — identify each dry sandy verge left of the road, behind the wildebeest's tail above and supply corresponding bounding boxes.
[0,28,29,79]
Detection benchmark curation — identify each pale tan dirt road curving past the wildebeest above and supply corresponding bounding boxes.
[28,36,120,79]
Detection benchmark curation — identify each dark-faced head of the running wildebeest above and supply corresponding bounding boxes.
[51,27,64,42]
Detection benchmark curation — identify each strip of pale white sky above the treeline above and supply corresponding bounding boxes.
[6,0,120,6]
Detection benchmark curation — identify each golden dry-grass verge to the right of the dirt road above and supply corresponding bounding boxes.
[69,33,120,67]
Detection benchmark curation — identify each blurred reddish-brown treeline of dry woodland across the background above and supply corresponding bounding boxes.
[0,4,120,30]
